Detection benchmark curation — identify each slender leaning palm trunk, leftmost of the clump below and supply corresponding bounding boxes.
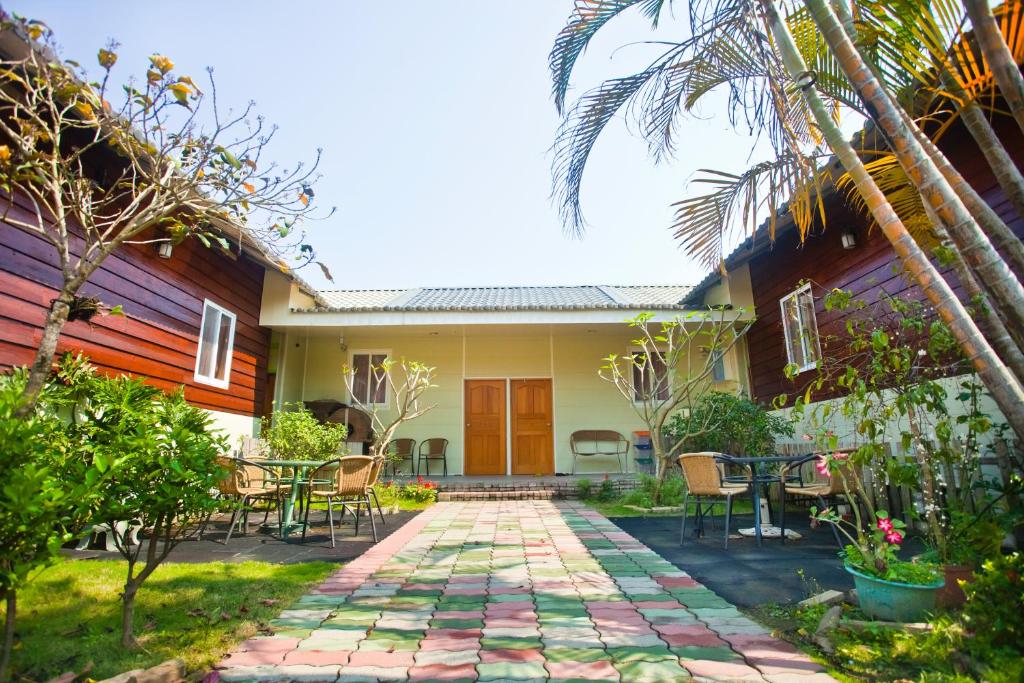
[761,0,1024,437]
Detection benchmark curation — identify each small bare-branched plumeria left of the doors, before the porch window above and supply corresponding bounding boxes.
[341,358,436,457]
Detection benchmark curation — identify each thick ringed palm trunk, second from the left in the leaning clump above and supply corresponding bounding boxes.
[804,0,1024,344]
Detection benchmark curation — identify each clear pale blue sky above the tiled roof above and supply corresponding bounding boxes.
[9,0,774,289]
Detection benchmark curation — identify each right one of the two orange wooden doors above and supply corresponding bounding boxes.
[511,380,555,474]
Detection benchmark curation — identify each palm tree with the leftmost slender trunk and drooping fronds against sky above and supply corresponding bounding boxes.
[551,0,1024,435]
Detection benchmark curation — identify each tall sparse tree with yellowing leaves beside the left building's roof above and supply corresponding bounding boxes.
[0,16,331,411]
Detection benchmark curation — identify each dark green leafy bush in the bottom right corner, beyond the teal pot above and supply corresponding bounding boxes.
[964,552,1024,654]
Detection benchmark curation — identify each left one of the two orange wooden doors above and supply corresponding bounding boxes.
[465,380,505,474]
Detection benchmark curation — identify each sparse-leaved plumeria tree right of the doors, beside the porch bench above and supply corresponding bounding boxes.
[598,308,754,505]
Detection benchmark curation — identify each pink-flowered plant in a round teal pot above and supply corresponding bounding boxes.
[811,453,945,622]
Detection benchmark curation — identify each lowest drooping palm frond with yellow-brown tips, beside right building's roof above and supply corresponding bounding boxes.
[672,154,830,270]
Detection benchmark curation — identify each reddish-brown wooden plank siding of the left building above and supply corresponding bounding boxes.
[0,192,270,416]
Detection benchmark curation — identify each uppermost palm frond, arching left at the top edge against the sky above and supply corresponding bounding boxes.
[548,0,672,114]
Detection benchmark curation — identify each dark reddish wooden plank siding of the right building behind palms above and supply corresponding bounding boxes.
[748,117,1024,402]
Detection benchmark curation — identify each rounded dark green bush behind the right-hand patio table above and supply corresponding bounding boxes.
[666,391,794,456]
